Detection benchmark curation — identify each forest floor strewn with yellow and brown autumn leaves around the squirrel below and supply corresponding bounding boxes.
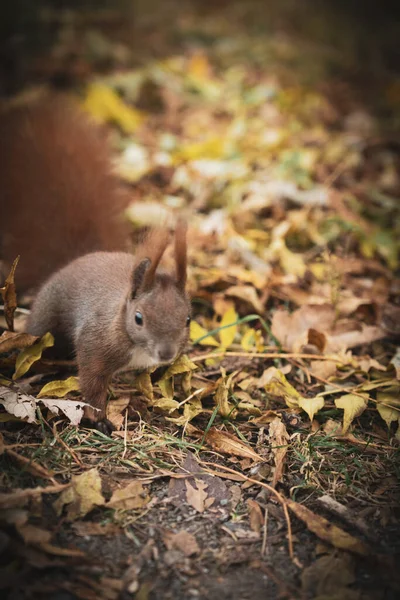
[0,1,400,600]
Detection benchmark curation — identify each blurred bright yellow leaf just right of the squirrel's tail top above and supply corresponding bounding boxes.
[83,83,143,133]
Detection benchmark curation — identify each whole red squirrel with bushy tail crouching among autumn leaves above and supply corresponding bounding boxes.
[0,98,190,431]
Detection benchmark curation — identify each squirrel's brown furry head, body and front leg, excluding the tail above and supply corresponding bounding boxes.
[27,229,190,421]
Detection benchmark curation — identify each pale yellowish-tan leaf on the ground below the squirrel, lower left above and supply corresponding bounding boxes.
[53,468,105,521]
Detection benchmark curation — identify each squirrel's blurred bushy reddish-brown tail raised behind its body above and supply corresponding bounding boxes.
[0,94,128,291]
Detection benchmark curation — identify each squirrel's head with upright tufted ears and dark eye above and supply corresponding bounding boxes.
[126,221,191,368]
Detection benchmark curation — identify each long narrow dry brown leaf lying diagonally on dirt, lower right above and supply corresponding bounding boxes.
[286,500,371,556]
